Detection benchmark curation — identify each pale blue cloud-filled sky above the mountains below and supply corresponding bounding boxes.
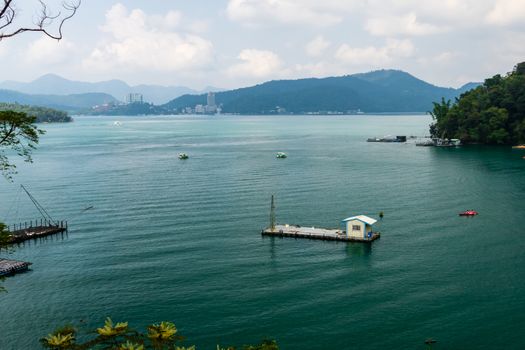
[0,0,525,89]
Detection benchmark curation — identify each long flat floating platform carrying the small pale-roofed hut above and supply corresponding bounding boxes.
[261,225,381,243]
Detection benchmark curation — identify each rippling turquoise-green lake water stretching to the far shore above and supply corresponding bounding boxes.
[0,116,525,349]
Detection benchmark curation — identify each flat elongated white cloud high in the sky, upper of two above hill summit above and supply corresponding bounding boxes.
[366,12,446,36]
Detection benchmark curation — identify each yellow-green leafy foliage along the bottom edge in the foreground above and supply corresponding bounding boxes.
[40,317,279,350]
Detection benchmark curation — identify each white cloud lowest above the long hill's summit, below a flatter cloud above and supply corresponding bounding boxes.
[335,39,414,66]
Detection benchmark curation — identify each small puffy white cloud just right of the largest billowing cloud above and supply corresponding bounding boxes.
[228,49,283,78]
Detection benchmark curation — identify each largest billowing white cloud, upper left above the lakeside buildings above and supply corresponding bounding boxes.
[83,3,213,71]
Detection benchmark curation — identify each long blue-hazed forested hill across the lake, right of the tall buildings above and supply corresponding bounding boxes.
[165,70,476,114]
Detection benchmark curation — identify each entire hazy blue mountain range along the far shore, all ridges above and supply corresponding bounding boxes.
[0,70,479,115]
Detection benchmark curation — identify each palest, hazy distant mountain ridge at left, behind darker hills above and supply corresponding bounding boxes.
[0,74,221,104]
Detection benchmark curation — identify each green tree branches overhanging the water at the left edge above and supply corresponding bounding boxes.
[0,111,44,180]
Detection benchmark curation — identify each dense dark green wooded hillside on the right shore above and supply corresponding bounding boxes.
[430,62,525,144]
